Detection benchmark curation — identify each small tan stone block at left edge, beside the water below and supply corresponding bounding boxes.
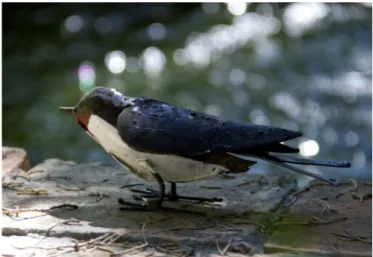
[2,146,30,180]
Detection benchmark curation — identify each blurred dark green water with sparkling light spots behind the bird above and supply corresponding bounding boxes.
[3,3,372,184]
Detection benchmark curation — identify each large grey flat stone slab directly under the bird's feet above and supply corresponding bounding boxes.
[3,159,296,256]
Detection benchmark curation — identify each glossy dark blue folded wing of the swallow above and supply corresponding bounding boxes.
[117,98,301,156]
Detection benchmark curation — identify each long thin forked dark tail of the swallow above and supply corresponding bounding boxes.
[228,153,351,186]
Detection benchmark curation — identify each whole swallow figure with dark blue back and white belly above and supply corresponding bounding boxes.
[59,87,351,210]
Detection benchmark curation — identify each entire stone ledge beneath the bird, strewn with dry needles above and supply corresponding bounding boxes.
[2,153,372,256]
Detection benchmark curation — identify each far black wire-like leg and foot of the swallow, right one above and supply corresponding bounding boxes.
[131,182,223,202]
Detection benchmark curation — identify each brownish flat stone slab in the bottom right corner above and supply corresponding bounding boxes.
[265,182,372,256]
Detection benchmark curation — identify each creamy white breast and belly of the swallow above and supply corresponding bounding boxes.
[88,115,226,182]
